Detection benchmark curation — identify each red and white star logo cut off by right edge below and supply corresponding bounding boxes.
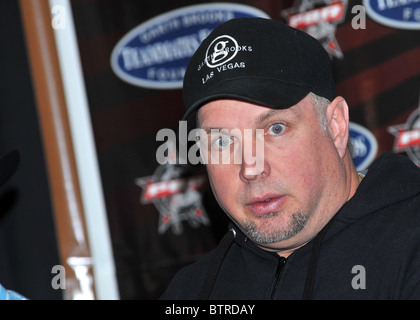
[388,95,420,166]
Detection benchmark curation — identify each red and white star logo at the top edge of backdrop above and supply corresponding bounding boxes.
[282,0,347,59]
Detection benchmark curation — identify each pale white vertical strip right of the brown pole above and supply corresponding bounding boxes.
[49,0,119,300]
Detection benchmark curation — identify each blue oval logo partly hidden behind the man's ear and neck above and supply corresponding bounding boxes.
[349,122,378,171]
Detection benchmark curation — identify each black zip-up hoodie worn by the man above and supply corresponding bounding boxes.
[162,153,420,300]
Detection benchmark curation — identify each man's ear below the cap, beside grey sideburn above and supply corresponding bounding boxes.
[326,96,349,158]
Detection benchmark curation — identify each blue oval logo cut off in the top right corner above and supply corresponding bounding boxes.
[363,0,420,29]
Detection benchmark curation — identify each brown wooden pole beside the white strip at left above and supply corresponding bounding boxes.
[20,0,95,300]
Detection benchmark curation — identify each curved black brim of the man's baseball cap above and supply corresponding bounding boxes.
[182,76,309,120]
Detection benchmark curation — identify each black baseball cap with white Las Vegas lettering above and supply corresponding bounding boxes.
[183,18,337,119]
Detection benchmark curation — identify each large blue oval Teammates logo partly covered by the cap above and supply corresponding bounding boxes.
[111,3,269,89]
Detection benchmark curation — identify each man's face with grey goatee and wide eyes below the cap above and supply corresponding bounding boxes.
[198,97,345,255]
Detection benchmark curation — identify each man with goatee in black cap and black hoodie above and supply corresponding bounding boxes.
[162,18,420,299]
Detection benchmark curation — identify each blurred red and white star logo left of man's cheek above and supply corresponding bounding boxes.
[135,142,210,235]
